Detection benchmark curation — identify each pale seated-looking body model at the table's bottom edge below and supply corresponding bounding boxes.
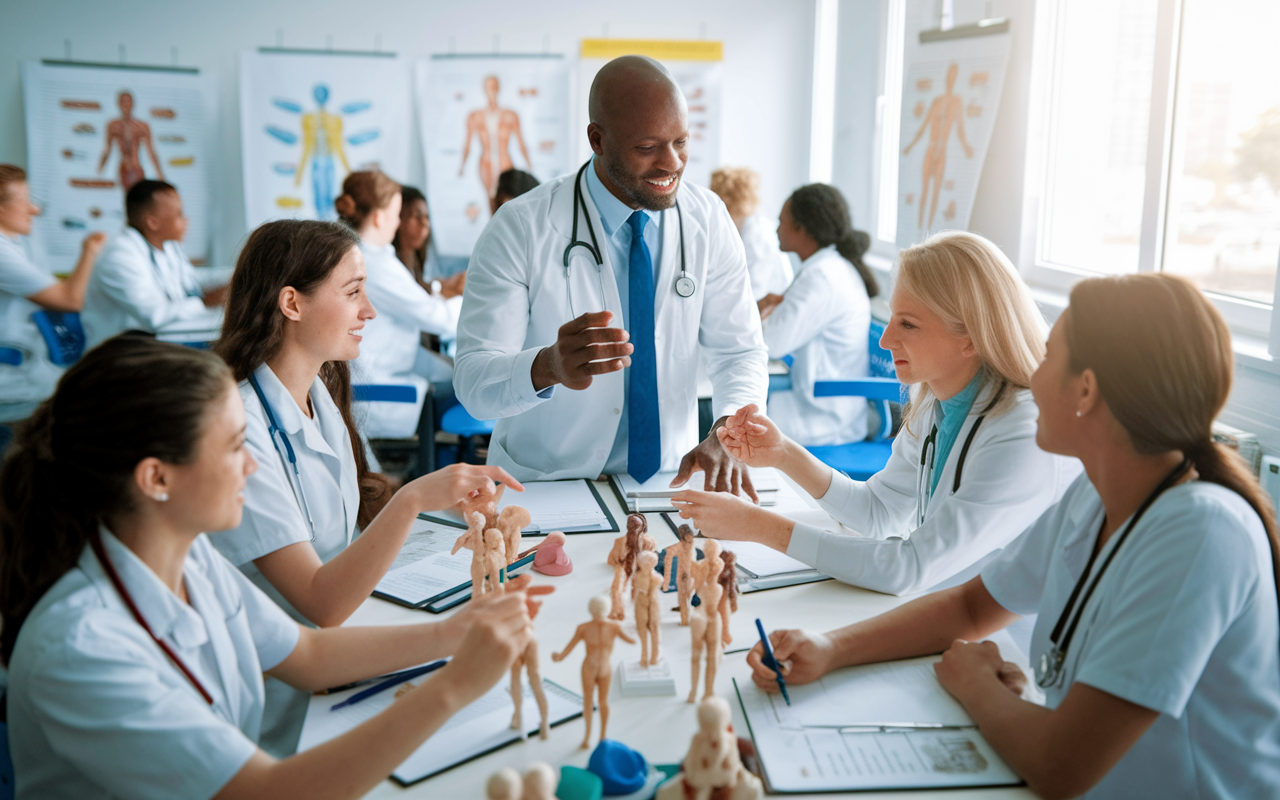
[657,698,764,800]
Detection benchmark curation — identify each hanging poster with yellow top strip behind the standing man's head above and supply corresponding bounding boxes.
[579,38,724,186]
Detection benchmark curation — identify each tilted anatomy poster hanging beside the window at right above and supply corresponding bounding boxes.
[897,28,1009,247]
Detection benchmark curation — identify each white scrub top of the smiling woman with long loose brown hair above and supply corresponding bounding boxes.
[212,364,360,758]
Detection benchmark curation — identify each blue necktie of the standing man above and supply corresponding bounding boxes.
[627,211,662,481]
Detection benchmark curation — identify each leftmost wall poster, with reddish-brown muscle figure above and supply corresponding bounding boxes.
[22,61,218,264]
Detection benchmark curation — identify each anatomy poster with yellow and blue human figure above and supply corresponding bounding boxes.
[239,51,412,228]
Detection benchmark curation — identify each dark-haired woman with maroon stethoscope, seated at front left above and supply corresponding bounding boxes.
[0,334,545,800]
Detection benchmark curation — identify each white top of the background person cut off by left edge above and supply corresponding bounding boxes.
[0,227,63,409]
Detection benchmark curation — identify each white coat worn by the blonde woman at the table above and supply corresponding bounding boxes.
[787,380,1082,594]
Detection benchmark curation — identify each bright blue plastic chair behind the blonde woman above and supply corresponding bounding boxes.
[805,320,906,480]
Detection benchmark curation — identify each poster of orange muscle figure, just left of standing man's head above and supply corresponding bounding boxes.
[416,55,572,256]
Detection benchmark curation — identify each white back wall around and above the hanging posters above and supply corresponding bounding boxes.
[0,0,814,262]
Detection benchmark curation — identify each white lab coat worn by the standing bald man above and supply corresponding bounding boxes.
[453,170,768,480]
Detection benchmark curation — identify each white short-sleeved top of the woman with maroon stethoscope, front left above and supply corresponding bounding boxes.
[8,529,298,800]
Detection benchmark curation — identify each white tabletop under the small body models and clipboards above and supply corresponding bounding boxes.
[347,475,1034,800]
